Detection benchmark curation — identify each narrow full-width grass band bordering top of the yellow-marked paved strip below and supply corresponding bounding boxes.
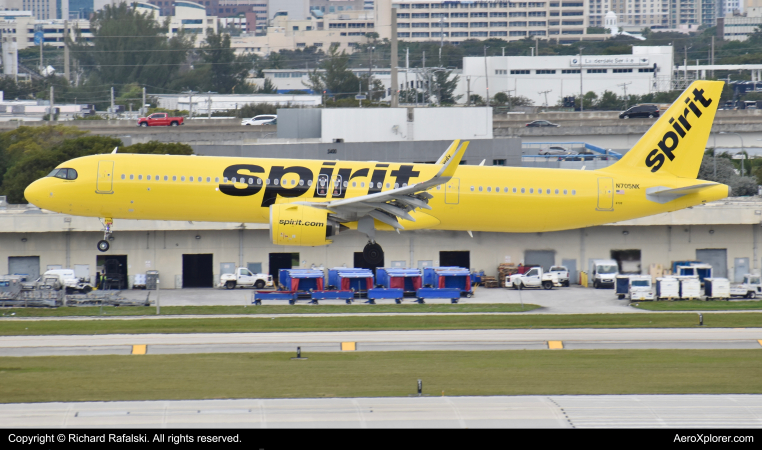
[0,313,762,336]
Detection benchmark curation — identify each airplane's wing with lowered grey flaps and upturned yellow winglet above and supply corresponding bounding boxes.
[298,140,469,229]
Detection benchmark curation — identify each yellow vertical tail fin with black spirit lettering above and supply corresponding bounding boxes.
[609,80,724,178]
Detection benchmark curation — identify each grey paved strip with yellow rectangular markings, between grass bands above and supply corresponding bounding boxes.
[0,328,762,356]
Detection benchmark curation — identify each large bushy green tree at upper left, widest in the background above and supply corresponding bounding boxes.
[68,2,191,87]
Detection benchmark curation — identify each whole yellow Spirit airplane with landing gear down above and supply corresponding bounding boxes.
[24,81,729,263]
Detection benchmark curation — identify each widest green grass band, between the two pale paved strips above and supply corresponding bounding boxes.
[0,350,762,403]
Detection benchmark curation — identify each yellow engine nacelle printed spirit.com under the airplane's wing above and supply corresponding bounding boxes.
[270,203,342,247]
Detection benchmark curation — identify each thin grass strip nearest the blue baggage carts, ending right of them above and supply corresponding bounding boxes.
[0,300,540,317]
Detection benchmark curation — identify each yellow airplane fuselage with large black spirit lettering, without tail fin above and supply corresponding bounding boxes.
[22,153,728,232]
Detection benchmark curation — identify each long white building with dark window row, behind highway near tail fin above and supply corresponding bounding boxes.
[456,46,674,106]
